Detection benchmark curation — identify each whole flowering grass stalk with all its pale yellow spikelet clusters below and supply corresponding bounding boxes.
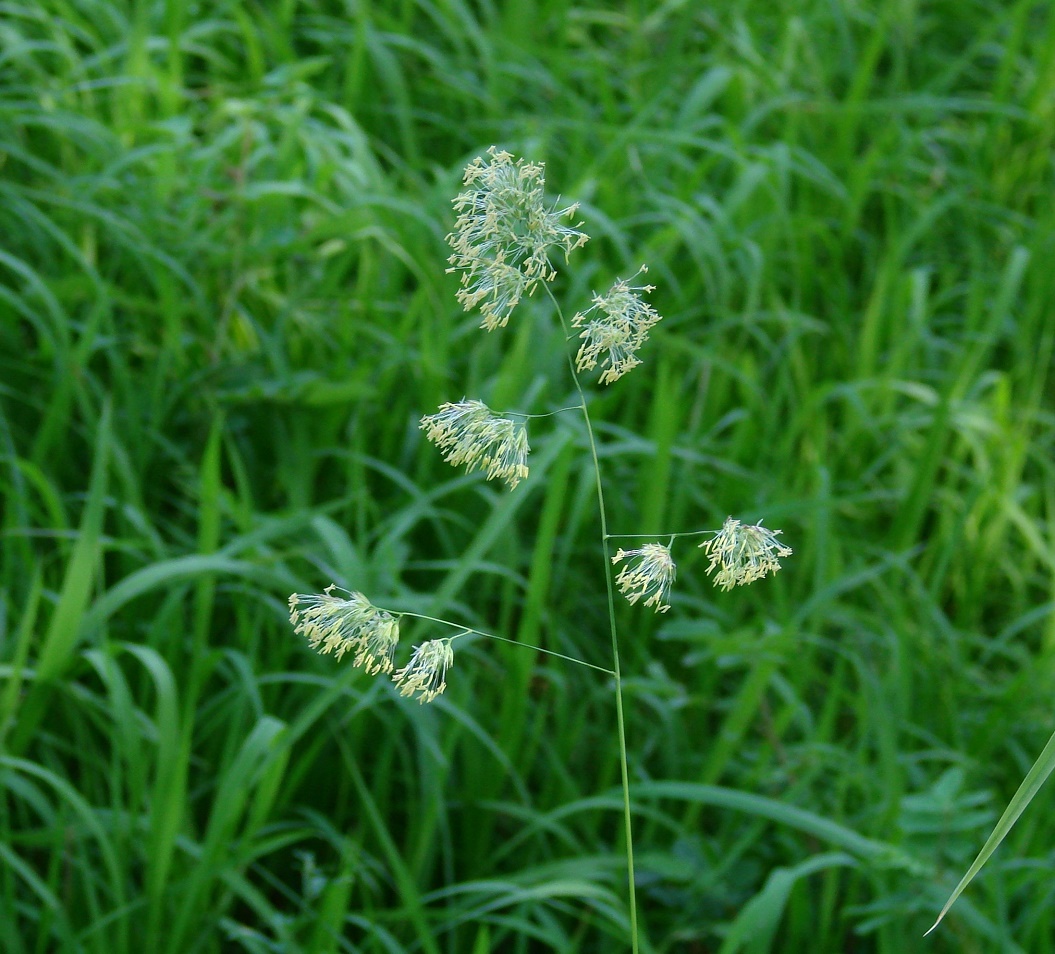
[289,147,791,954]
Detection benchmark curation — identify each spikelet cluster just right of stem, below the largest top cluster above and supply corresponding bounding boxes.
[572,265,663,384]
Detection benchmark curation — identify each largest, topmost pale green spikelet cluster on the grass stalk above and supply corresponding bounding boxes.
[447,146,589,331]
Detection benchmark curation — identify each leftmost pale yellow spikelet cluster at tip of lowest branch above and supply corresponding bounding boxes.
[289,584,399,675]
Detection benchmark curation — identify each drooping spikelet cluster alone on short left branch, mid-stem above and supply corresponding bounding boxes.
[421,398,530,490]
